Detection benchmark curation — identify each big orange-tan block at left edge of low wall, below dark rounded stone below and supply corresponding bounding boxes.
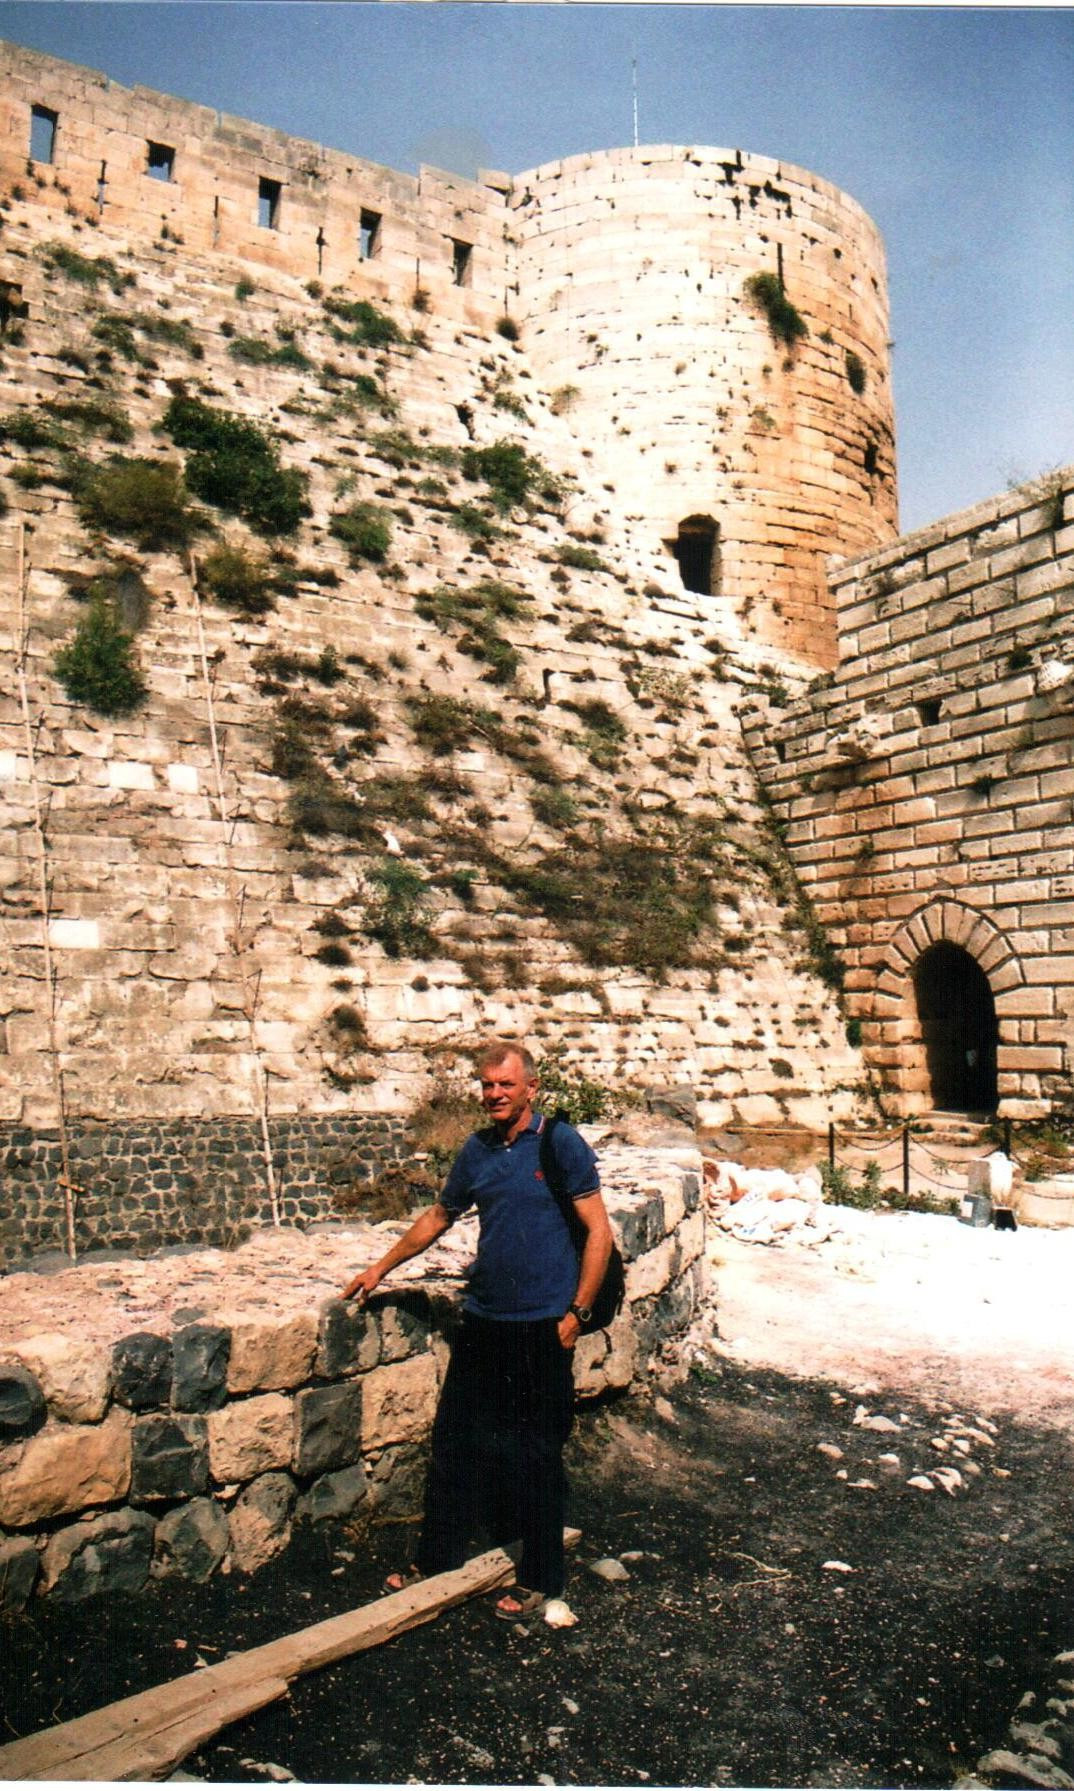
[0,1406,131,1530]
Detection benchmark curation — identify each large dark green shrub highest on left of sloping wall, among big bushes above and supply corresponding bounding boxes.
[163,396,310,536]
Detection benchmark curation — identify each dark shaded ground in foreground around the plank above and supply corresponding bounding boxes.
[4,1365,1074,1787]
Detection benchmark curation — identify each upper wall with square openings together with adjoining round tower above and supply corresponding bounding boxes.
[0,45,897,663]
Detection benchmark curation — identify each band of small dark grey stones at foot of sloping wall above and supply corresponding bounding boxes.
[0,1114,406,1266]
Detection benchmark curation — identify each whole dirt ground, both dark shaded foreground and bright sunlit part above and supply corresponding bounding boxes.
[4,1209,1074,1787]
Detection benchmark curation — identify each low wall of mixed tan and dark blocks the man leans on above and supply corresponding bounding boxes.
[0,1144,705,1610]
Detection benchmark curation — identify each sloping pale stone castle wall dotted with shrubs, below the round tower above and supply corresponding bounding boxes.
[0,34,880,1257]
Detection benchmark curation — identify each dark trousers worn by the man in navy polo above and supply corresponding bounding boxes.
[417,1316,575,1598]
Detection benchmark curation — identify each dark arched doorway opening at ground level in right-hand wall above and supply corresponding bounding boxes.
[913,942,999,1112]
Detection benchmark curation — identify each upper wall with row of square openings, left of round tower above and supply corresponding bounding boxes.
[0,45,507,321]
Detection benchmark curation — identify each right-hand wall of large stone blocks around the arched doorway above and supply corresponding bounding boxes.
[746,467,1074,1118]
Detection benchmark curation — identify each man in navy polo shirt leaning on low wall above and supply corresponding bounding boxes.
[344,1039,612,1623]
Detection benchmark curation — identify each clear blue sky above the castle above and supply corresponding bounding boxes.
[0,0,1074,528]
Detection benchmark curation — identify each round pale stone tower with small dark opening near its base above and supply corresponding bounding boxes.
[510,147,897,664]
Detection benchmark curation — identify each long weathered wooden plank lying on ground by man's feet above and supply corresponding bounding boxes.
[0,1530,580,1782]
